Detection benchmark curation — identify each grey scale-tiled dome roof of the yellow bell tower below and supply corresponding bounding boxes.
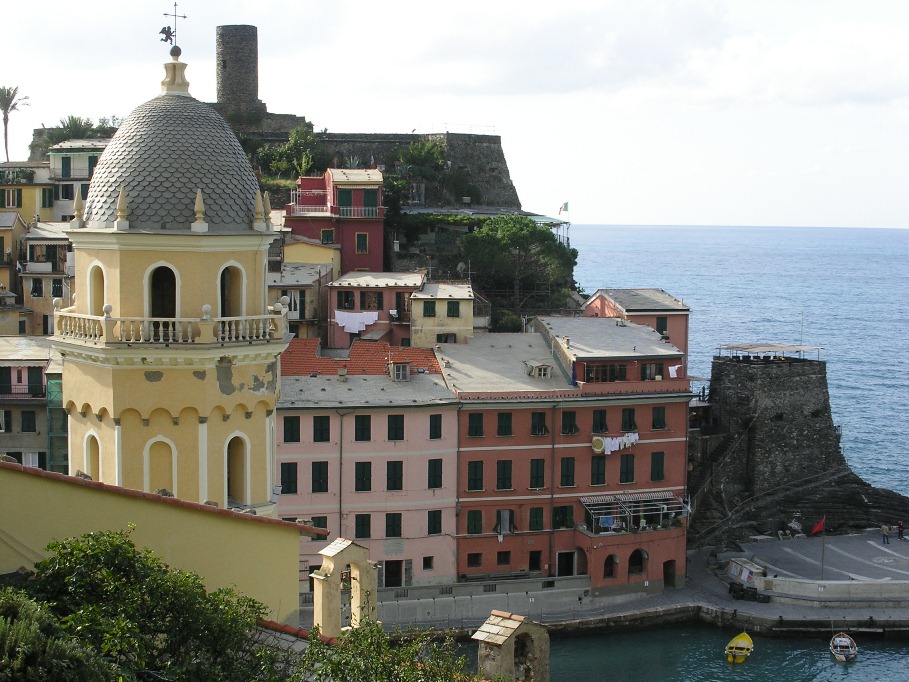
[85,58,259,232]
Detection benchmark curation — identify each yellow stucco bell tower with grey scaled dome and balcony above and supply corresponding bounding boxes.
[54,47,289,514]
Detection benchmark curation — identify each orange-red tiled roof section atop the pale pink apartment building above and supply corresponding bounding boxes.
[281,339,442,377]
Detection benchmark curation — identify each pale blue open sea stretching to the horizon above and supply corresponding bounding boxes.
[570,225,909,494]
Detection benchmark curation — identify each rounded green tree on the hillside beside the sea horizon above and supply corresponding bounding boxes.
[461,215,578,312]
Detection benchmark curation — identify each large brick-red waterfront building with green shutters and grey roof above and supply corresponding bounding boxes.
[437,310,691,596]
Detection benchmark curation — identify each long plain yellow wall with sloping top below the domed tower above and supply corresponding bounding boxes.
[0,464,300,624]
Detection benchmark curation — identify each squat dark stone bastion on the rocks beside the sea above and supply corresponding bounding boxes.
[710,357,845,495]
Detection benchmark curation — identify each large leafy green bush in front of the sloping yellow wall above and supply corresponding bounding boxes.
[31,531,286,682]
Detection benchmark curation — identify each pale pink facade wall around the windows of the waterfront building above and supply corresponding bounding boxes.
[277,405,457,585]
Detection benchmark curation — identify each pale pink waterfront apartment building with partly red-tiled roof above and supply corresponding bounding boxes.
[277,339,457,587]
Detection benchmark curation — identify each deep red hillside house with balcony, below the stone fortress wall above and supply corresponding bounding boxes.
[284,168,385,275]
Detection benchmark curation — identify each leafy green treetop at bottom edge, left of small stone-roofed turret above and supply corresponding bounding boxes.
[293,619,479,682]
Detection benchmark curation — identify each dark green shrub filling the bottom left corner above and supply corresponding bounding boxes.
[0,589,116,682]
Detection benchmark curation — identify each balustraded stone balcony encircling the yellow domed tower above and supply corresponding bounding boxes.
[54,299,288,346]
